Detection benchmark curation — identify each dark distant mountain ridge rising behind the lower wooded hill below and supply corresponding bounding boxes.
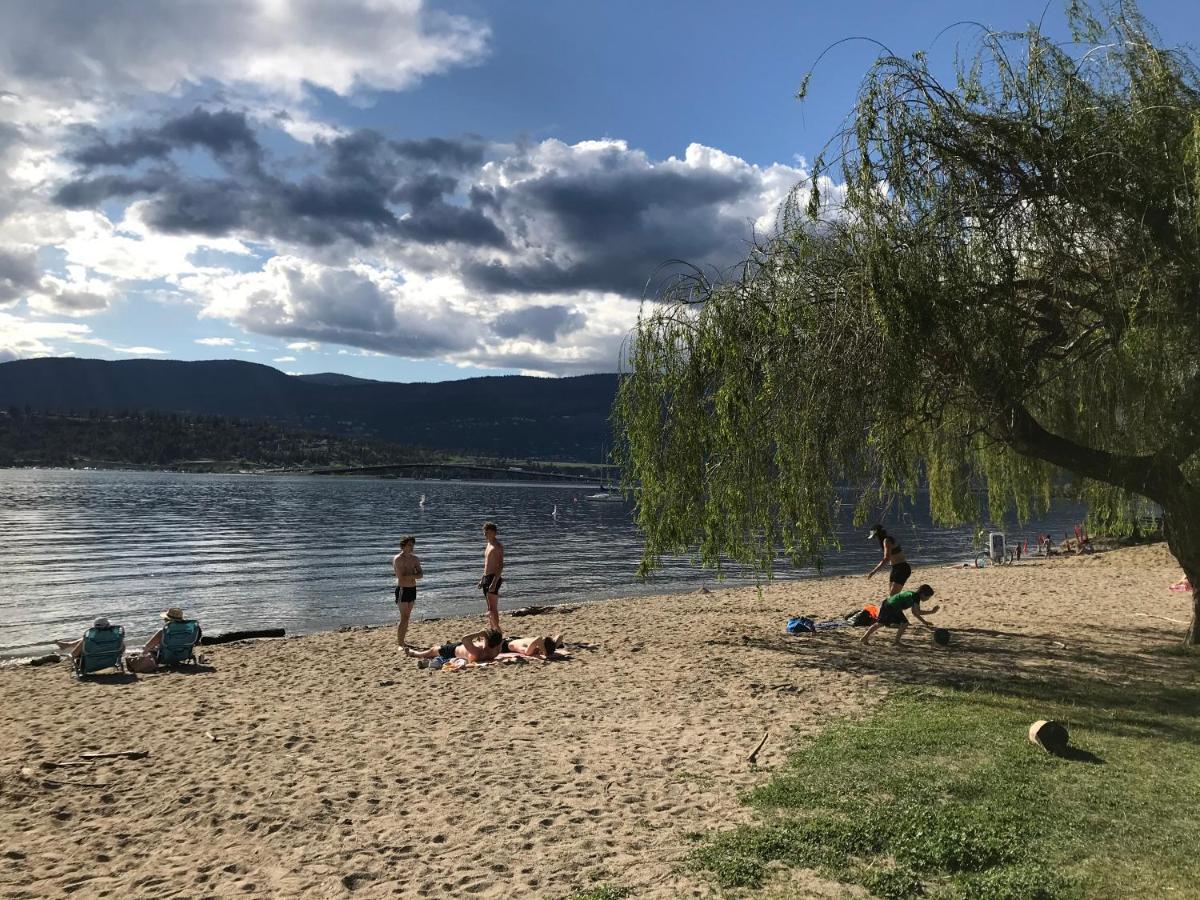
[0,358,617,462]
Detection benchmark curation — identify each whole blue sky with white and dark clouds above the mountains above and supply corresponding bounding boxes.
[0,0,1200,382]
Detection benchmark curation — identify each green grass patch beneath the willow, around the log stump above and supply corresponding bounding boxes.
[691,654,1200,900]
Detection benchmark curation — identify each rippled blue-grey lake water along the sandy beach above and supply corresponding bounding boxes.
[0,469,1084,656]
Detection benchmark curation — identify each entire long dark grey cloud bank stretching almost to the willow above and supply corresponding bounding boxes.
[56,108,792,296]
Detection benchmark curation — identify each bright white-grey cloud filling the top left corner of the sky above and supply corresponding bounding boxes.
[0,0,488,97]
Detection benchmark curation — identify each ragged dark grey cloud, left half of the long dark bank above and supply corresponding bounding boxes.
[55,116,504,247]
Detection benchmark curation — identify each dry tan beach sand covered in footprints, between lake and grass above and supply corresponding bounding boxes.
[0,546,1188,898]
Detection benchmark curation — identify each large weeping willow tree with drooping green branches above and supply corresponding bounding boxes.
[614,6,1200,643]
